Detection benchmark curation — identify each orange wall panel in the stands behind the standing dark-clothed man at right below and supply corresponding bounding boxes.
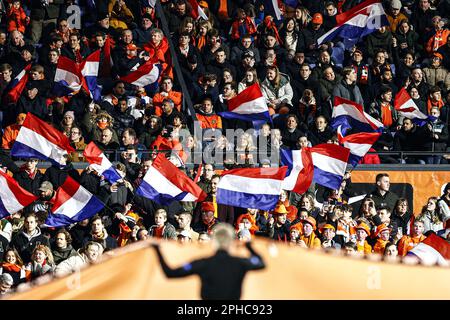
[352,170,450,215]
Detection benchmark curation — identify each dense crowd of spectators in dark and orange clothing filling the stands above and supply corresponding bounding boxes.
[0,0,450,293]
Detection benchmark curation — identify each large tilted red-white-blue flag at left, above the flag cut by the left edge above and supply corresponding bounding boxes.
[11,112,75,165]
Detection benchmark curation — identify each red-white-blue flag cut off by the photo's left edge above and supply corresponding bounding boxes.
[0,170,37,219]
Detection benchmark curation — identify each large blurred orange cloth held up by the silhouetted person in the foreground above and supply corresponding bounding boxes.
[7,240,450,300]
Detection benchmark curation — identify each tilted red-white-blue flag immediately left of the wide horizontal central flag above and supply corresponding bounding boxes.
[136,153,206,204]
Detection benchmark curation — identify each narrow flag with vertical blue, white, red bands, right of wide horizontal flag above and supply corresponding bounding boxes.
[280,148,314,193]
